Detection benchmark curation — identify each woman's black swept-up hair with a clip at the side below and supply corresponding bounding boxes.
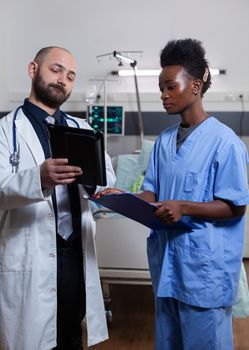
[160,39,211,96]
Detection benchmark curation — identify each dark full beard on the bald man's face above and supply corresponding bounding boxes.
[33,71,71,109]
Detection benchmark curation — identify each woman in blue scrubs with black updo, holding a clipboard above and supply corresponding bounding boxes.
[96,39,249,350]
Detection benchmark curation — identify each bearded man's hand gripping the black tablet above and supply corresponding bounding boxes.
[40,158,82,188]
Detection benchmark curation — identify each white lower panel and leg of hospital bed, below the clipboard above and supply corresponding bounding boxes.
[94,210,151,322]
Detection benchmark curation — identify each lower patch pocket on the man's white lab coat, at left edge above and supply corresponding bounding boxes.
[0,228,34,273]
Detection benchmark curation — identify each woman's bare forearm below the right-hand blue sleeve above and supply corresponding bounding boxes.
[180,199,246,219]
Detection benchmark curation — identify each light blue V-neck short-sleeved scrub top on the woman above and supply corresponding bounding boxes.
[142,117,249,308]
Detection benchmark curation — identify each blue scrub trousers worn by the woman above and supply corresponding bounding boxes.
[156,298,233,350]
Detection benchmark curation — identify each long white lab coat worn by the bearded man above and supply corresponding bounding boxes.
[0,110,115,350]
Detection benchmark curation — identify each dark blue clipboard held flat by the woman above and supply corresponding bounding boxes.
[89,192,193,231]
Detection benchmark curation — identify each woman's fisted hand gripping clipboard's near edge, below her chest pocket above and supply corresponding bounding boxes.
[154,200,182,224]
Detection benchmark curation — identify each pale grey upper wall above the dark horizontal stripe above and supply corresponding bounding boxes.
[0,0,249,112]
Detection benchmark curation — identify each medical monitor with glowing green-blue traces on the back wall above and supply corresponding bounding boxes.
[87,105,125,136]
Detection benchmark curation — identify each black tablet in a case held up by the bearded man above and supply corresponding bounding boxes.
[48,124,107,186]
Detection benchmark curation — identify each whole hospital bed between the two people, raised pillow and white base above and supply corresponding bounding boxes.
[93,140,154,321]
